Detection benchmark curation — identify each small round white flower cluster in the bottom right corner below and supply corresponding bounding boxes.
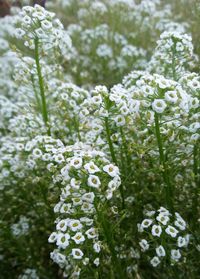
[138,207,190,267]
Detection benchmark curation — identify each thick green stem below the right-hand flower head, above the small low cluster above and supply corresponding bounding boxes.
[155,112,174,213]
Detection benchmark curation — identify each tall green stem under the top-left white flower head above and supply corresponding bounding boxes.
[35,38,51,136]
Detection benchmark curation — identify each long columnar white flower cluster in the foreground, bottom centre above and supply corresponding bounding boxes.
[49,151,121,278]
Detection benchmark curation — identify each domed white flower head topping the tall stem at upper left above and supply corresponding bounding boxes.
[15,5,71,55]
